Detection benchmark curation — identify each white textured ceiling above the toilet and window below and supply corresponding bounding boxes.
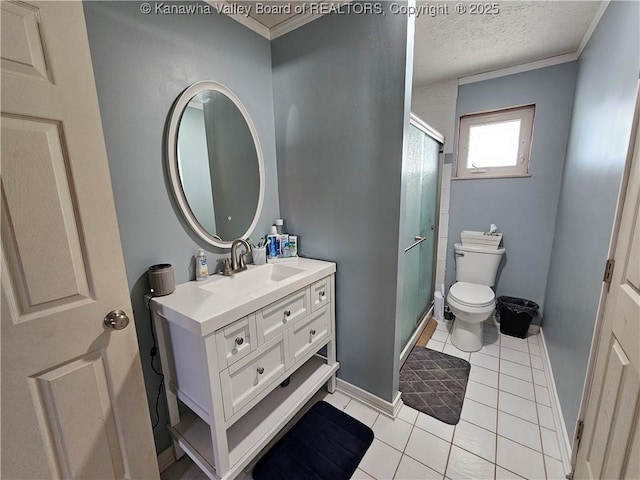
[413,0,601,87]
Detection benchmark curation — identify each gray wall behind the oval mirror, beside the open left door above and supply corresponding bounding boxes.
[84,1,279,451]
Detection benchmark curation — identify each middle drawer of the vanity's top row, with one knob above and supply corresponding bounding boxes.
[256,288,311,345]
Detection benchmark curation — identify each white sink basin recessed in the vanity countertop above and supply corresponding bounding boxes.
[199,264,304,297]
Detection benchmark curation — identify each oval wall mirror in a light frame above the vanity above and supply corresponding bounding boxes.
[167,81,264,248]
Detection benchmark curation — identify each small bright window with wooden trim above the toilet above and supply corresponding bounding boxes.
[456,105,535,178]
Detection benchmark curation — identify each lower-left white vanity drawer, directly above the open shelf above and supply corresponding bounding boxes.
[220,335,285,420]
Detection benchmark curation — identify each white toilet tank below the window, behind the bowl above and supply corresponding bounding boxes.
[453,243,505,287]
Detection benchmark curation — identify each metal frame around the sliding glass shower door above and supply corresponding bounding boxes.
[399,112,445,366]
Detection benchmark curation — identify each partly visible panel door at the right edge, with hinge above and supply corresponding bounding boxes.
[574,93,640,479]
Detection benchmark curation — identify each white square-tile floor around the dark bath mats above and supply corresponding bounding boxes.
[162,323,565,480]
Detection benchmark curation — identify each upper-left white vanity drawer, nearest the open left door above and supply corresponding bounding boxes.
[215,314,257,370]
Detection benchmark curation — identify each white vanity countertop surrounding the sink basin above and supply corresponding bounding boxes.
[151,258,336,336]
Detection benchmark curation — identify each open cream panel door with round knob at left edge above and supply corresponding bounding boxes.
[0,1,159,479]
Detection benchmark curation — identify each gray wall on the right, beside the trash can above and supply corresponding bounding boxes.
[544,1,640,436]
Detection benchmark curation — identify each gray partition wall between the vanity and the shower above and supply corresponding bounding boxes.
[271,4,408,401]
